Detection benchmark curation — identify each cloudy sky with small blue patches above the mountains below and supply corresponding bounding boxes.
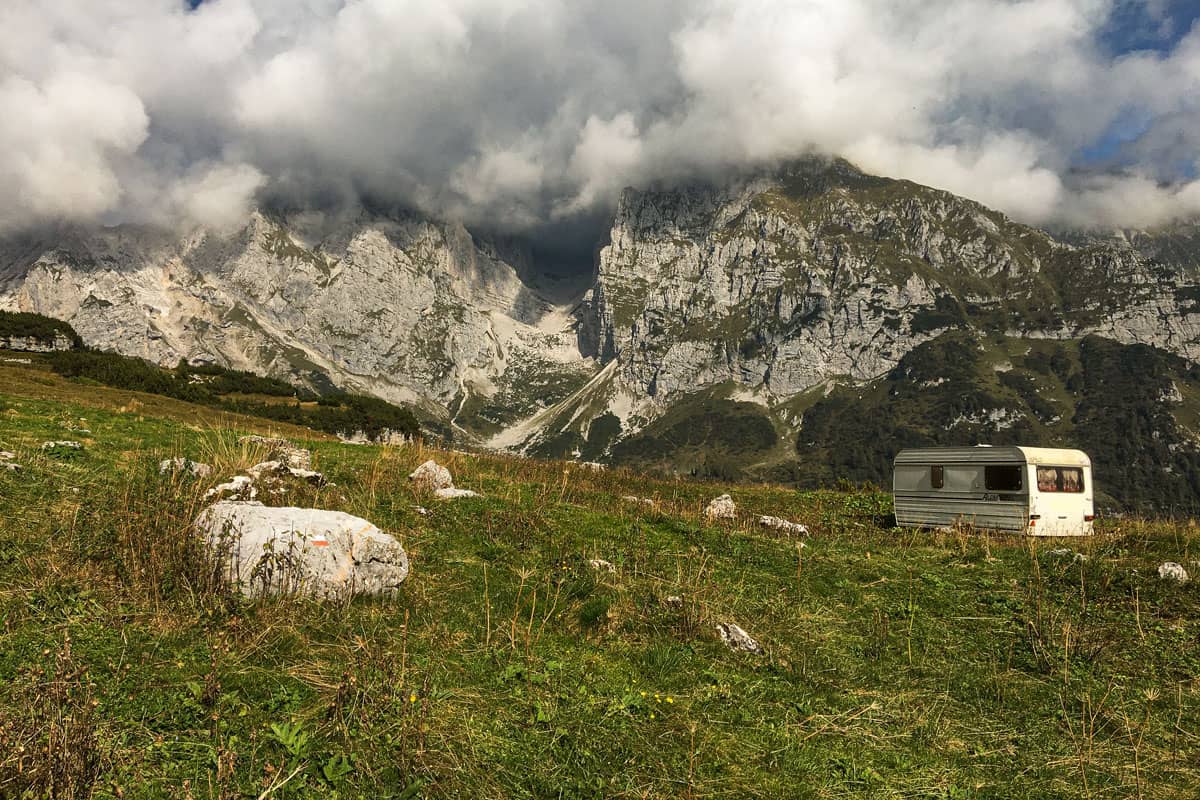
[0,0,1200,233]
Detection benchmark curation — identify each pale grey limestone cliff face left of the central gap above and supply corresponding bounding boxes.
[0,213,582,424]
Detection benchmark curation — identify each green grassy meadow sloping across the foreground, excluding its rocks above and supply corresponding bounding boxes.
[0,385,1200,799]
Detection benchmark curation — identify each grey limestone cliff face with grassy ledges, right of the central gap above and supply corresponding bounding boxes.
[595,162,1200,398]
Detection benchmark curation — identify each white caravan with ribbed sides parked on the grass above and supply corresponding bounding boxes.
[892,446,1096,536]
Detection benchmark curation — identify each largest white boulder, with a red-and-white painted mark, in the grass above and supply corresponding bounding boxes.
[196,503,408,599]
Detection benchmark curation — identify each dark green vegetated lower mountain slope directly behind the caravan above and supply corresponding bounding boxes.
[787,331,1200,516]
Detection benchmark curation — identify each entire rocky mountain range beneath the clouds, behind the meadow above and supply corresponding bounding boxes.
[0,160,1200,509]
